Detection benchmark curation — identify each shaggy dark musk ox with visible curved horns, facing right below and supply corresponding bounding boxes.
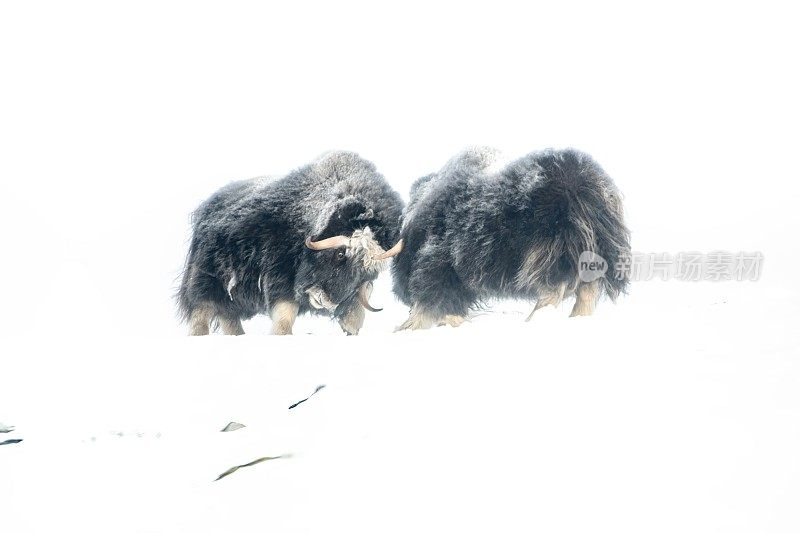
[177,152,403,335]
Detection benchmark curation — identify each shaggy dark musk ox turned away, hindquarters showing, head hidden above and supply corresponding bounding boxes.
[392,148,630,329]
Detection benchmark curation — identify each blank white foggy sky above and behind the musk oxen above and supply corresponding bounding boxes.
[0,2,800,332]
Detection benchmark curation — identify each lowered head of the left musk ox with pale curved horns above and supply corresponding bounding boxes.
[297,226,403,316]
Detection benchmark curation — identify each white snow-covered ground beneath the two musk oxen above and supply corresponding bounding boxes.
[0,279,800,532]
